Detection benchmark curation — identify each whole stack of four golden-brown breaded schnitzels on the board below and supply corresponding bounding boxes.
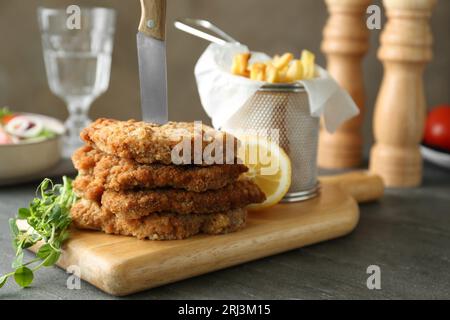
[71,119,265,240]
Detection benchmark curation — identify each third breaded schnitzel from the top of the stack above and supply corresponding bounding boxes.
[93,180,266,219]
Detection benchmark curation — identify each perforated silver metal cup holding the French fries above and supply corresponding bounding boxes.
[224,84,319,202]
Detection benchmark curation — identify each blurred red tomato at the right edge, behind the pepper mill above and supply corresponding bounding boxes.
[424,104,450,151]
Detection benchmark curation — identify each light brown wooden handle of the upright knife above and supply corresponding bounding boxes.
[139,0,166,41]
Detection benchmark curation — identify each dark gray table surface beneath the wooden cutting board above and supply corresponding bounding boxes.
[0,165,450,300]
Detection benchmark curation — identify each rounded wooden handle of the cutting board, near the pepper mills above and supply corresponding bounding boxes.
[320,171,384,203]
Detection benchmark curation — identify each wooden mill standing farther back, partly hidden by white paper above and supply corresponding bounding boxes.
[318,0,371,169]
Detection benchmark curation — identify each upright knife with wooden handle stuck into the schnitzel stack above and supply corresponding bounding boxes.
[137,0,168,124]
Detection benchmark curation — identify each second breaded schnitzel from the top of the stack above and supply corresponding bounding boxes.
[72,146,248,200]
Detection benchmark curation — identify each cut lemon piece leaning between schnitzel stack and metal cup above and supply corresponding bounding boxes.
[239,136,292,210]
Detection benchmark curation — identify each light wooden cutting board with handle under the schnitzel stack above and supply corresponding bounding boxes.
[34,172,383,296]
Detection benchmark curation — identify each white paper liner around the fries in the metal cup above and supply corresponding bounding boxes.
[195,44,359,133]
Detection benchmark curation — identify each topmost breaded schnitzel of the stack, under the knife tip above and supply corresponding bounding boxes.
[80,119,238,164]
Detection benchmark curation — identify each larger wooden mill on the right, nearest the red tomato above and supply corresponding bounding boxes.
[370,0,436,187]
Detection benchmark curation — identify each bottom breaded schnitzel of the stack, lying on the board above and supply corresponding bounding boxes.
[70,199,247,240]
